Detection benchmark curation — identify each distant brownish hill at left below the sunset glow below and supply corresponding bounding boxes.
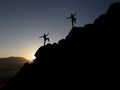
[0,57,28,87]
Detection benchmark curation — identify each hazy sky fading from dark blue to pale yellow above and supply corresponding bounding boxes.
[0,0,120,59]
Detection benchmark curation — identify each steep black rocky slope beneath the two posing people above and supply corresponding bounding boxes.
[2,2,120,90]
